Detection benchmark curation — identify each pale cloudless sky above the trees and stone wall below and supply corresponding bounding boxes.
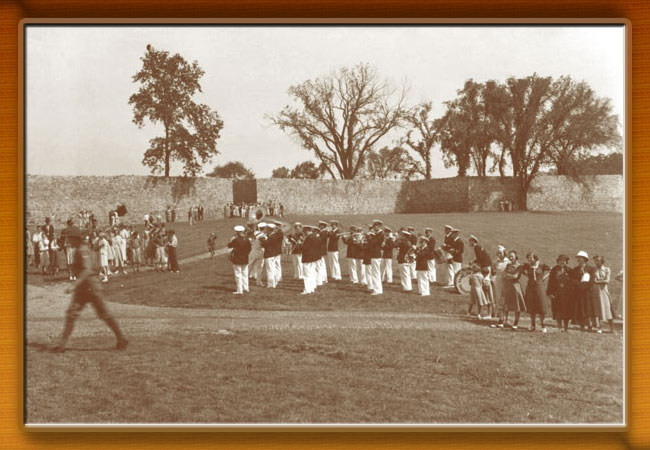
[26,25,625,178]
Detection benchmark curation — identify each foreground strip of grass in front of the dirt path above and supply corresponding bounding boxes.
[27,327,622,423]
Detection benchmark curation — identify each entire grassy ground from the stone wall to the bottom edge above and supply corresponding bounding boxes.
[26,213,623,424]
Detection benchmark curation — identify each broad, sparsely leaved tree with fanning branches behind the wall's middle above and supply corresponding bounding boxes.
[268,64,405,179]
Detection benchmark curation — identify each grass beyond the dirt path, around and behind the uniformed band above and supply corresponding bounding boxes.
[100,213,622,314]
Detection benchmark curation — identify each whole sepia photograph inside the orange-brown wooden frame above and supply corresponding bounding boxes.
[21,20,629,429]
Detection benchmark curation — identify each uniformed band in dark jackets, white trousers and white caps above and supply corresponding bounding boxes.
[228,216,464,296]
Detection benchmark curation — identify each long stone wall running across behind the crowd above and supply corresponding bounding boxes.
[25,175,624,227]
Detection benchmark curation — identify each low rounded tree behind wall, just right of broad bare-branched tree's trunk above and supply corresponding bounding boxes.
[366,147,423,180]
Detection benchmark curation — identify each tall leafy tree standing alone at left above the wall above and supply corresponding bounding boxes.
[129,45,223,177]
